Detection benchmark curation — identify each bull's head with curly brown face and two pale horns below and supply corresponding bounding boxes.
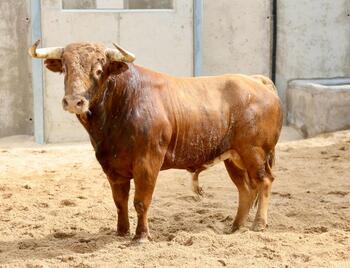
[29,40,135,114]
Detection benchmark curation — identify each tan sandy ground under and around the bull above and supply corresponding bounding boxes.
[0,131,350,267]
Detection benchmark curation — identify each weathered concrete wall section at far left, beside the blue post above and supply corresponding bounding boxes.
[0,0,33,137]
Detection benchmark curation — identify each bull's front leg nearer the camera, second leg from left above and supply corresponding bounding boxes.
[133,158,162,242]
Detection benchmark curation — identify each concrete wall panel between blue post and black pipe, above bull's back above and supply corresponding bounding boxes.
[203,0,272,75]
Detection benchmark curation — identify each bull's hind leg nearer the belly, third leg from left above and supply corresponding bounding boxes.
[225,159,256,232]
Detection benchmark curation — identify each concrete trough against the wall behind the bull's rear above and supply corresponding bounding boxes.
[286,78,350,138]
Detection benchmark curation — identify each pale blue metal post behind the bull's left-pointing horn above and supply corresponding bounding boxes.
[31,0,45,144]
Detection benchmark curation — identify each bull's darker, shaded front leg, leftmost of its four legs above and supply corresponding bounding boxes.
[108,176,130,236]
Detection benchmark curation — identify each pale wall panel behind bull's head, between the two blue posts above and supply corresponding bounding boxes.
[41,0,193,142]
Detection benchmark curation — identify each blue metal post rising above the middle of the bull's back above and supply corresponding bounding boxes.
[193,0,203,76]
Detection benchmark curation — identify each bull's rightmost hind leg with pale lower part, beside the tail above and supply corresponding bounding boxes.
[243,147,273,231]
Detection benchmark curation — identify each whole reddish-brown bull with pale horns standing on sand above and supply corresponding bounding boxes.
[30,42,282,240]
